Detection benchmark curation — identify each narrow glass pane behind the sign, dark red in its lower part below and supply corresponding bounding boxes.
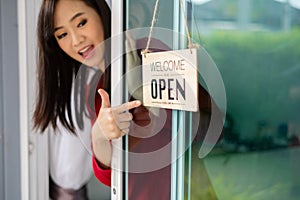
[125,0,173,200]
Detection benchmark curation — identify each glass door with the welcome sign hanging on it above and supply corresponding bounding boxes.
[125,0,300,200]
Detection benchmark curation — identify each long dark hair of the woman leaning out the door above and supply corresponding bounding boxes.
[33,0,111,133]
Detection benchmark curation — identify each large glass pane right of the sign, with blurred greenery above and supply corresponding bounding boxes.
[191,0,300,200]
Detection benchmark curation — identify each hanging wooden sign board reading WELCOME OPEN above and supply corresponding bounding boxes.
[142,48,198,112]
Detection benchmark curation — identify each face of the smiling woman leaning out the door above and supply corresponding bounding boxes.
[54,0,104,69]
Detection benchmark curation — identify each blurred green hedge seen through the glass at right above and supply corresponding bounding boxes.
[195,29,300,138]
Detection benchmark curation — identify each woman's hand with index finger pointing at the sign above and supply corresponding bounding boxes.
[96,89,141,140]
